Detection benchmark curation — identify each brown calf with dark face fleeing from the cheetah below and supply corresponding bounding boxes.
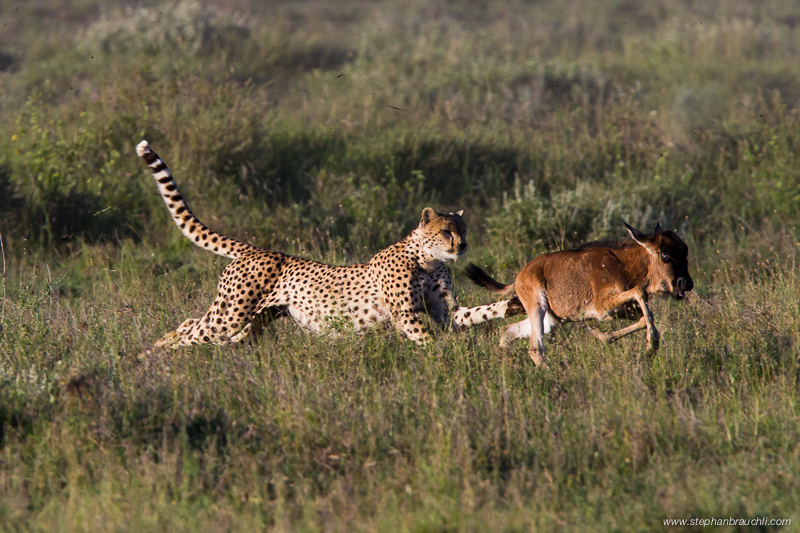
[467,223,694,365]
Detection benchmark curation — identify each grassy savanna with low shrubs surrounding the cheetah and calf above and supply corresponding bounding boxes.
[0,0,800,531]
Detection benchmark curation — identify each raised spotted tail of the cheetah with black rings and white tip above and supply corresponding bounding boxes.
[136,141,255,259]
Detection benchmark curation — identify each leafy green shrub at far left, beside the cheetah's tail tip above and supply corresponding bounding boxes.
[4,98,137,246]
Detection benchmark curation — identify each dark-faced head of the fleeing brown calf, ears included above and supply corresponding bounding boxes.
[625,223,694,300]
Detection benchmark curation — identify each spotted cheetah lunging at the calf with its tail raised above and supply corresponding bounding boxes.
[136,141,523,349]
